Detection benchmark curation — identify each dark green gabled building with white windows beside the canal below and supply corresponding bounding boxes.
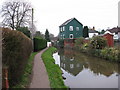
[59,18,83,39]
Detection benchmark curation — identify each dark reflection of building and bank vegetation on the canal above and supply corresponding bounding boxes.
[59,49,119,77]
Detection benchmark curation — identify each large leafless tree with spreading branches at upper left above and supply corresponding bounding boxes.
[1,1,32,30]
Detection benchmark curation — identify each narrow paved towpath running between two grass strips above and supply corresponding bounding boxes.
[29,48,50,88]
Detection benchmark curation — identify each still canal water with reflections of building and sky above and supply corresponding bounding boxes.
[53,49,118,88]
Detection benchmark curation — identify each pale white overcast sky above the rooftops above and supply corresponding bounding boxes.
[0,0,120,36]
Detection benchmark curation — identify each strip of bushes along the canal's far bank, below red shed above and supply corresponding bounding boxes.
[75,37,120,62]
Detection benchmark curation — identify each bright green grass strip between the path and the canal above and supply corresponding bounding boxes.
[42,47,67,88]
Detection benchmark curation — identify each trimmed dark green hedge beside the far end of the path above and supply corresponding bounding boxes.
[34,37,47,52]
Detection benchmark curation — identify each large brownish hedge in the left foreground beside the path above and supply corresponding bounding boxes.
[2,28,32,87]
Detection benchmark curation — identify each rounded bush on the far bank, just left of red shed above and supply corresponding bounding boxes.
[90,36,107,49]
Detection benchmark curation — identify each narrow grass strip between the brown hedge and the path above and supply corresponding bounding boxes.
[12,52,37,88]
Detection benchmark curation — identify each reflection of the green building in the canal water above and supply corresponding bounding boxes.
[60,51,83,76]
